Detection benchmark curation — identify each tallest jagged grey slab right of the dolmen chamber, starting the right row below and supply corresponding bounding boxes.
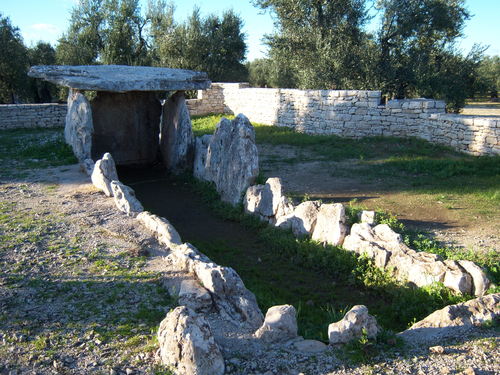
[201,114,259,205]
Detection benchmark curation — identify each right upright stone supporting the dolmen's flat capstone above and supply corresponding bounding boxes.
[160,91,194,173]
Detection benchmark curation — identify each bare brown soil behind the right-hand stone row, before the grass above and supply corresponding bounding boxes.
[259,144,500,251]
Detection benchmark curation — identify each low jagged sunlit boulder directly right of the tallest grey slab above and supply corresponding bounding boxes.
[243,177,293,224]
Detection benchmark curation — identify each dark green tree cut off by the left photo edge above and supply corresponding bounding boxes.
[0,13,28,104]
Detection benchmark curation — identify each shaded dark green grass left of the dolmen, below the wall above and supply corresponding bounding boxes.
[0,128,77,178]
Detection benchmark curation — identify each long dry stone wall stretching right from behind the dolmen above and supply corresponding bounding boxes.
[188,83,500,155]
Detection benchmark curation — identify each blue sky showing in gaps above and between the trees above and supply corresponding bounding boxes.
[0,0,500,60]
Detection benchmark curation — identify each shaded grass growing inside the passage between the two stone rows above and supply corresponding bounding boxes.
[177,181,470,340]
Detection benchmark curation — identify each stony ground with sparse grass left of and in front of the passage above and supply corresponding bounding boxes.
[0,166,500,375]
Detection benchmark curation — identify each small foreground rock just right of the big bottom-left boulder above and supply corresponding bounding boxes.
[255,305,297,343]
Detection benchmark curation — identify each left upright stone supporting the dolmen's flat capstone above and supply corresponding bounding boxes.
[64,90,93,162]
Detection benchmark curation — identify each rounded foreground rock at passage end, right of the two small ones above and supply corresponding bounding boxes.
[328,305,379,344]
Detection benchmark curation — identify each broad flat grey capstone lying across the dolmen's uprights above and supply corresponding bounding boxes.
[28,65,211,92]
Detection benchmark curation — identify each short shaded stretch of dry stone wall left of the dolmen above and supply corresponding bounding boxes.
[0,103,67,129]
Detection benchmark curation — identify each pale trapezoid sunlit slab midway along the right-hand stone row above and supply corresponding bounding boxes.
[312,203,347,246]
